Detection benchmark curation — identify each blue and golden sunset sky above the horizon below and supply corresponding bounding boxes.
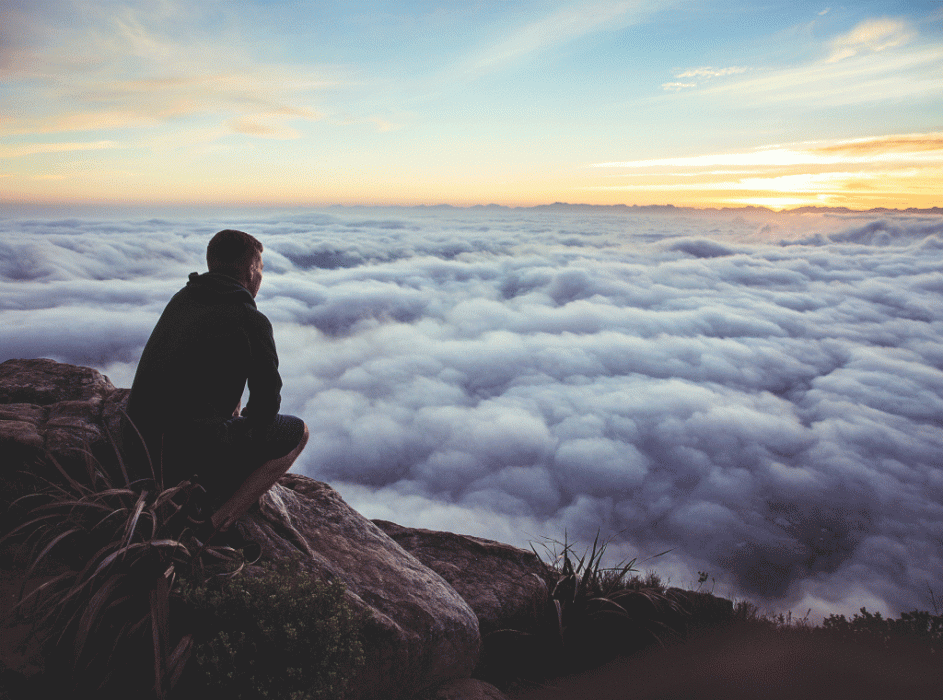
[0,0,943,209]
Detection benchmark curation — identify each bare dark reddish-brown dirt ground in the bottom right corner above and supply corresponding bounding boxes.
[507,632,943,700]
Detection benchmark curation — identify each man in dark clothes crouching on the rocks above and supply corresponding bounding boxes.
[128,229,308,531]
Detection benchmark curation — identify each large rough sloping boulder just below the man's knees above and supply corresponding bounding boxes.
[249,474,480,700]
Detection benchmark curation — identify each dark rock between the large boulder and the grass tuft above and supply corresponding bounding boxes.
[373,520,550,636]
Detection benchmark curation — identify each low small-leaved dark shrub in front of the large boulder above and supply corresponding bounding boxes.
[178,560,363,700]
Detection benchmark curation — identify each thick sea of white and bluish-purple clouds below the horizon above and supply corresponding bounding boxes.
[0,208,943,621]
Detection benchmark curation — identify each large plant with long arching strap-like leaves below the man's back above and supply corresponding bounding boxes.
[3,430,241,698]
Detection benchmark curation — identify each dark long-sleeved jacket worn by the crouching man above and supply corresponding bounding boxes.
[128,272,282,464]
